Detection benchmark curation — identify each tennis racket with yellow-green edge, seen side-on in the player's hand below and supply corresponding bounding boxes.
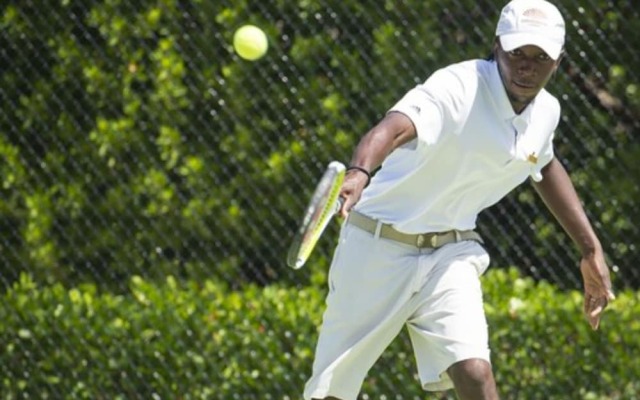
[287,161,346,269]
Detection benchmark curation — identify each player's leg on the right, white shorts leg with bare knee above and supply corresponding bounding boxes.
[407,242,495,394]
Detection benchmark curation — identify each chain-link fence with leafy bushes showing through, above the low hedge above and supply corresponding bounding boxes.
[0,0,640,399]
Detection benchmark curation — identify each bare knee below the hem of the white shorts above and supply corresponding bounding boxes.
[447,358,498,400]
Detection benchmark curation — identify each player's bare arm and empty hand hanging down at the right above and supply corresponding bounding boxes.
[532,158,615,329]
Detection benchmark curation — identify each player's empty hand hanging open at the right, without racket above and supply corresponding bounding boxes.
[580,251,615,330]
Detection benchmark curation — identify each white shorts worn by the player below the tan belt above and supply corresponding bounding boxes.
[304,223,490,400]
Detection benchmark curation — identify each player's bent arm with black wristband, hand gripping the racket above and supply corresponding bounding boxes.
[340,112,417,218]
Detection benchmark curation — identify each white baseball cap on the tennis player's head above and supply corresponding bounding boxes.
[496,0,565,60]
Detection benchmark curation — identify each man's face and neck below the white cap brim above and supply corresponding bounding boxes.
[493,40,562,113]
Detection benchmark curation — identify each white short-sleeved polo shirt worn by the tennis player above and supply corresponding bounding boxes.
[355,60,560,233]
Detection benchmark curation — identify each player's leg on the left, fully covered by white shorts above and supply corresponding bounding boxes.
[304,223,418,400]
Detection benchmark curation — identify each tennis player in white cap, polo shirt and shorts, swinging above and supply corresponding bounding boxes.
[304,0,614,400]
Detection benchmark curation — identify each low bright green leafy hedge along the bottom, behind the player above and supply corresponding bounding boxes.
[0,269,640,399]
